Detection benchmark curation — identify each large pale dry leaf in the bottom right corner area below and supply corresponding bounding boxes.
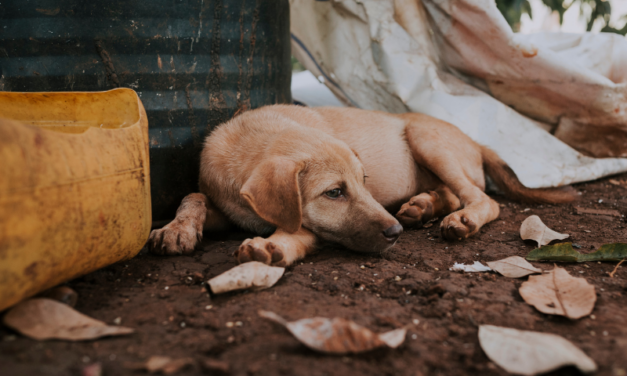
[479,325,597,375]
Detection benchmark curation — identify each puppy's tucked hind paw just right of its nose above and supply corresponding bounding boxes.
[396,184,460,228]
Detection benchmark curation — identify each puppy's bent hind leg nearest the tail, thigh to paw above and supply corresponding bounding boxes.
[404,114,499,240]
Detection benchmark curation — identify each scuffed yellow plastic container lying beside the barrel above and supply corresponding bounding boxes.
[0,89,151,310]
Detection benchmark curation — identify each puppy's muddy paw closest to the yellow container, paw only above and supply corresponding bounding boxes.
[148,219,202,255]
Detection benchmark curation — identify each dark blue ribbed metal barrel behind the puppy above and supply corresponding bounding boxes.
[0,0,291,221]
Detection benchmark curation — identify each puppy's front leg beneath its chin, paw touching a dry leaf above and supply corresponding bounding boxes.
[235,227,317,266]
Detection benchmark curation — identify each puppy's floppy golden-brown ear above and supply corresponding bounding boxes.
[239,157,302,233]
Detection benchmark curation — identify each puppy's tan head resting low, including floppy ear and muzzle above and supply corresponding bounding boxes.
[240,128,403,252]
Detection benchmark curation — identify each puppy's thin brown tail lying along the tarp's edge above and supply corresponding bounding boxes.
[481,146,577,204]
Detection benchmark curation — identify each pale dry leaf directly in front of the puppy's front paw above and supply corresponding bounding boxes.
[208,261,285,294]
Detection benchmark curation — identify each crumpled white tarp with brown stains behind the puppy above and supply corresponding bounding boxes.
[290,0,627,187]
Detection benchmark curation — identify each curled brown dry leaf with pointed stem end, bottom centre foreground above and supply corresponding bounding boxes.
[259,311,407,354]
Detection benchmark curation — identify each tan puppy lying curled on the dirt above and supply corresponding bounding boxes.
[149,105,575,265]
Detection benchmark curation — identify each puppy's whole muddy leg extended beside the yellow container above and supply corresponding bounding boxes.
[148,193,230,255]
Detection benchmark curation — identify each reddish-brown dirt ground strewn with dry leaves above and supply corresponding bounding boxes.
[0,174,627,376]
